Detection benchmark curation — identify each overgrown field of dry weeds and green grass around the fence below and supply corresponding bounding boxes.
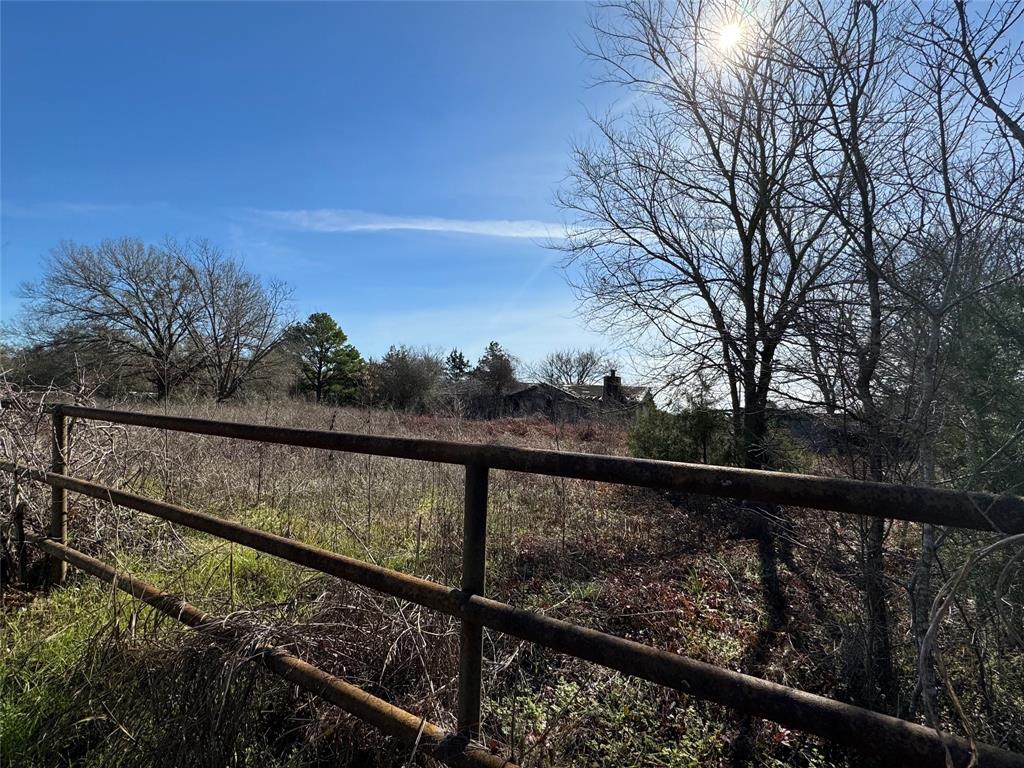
[0,402,1024,768]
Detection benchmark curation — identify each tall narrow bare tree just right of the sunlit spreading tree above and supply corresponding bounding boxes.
[778,0,906,709]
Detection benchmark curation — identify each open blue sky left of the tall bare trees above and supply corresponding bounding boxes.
[0,2,623,370]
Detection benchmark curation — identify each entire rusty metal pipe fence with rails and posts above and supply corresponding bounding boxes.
[6,406,1024,767]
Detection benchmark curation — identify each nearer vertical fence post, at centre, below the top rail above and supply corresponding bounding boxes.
[459,464,487,738]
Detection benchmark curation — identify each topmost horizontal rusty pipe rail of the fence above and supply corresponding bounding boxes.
[54,406,1024,534]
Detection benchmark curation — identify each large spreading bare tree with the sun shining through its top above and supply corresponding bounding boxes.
[560,0,843,467]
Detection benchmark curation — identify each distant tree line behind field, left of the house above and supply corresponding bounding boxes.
[0,238,608,416]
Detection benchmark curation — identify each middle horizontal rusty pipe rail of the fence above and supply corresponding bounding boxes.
[0,463,1024,767]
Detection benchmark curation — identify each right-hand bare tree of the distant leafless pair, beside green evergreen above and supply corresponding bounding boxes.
[177,240,291,401]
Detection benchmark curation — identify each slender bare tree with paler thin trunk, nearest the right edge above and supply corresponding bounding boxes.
[888,20,1021,712]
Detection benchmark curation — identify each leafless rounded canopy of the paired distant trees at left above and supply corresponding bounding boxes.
[23,238,290,399]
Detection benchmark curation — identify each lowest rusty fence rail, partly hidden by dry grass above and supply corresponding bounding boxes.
[35,539,516,768]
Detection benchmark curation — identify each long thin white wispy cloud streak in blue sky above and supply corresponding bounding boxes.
[250,208,563,239]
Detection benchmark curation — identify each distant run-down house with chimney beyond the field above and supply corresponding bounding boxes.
[502,370,652,421]
